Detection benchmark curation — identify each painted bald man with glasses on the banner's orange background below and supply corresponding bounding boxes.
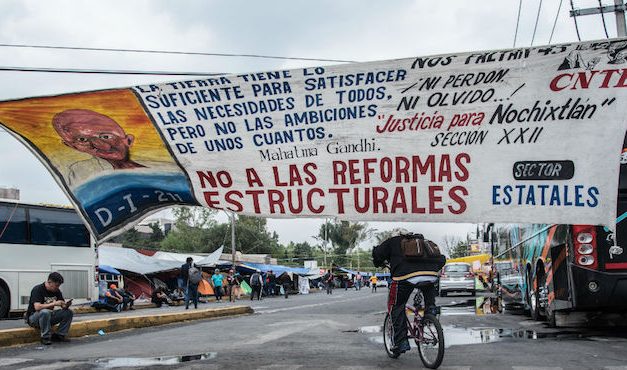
[52,109,171,186]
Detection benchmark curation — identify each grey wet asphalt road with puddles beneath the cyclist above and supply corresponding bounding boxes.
[0,289,627,370]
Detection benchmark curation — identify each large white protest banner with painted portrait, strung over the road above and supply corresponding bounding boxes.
[0,40,627,240]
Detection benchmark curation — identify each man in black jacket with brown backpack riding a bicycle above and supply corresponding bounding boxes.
[372,233,446,354]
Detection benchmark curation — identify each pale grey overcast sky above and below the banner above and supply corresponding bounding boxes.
[0,0,616,247]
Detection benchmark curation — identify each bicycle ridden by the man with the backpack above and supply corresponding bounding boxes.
[383,290,444,369]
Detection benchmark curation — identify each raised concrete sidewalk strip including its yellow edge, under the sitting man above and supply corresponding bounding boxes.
[0,303,253,347]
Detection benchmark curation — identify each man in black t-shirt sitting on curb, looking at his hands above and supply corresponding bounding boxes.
[26,272,74,345]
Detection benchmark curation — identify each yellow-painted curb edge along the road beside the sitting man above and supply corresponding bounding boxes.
[0,306,254,347]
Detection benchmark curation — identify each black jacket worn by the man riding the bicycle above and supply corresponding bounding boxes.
[372,236,446,281]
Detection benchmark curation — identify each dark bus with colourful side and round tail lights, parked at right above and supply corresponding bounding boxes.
[484,141,627,326]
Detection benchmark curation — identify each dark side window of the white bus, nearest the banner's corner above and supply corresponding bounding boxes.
[28,208,89,247]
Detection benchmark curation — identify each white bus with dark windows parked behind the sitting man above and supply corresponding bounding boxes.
[0,201,98,318]
